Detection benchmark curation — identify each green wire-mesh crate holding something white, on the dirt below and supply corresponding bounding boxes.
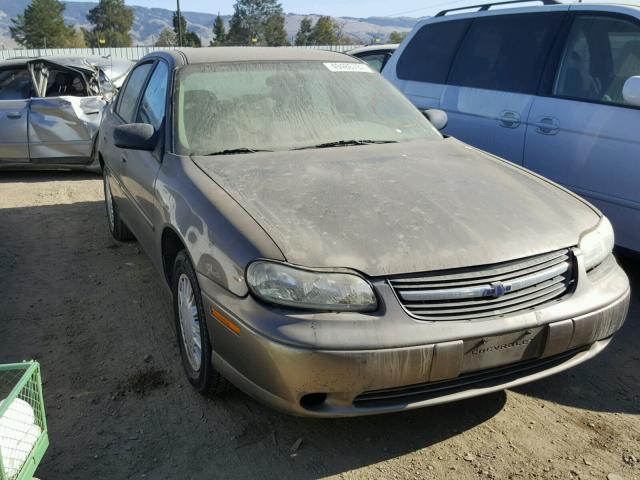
[0,361,49,480]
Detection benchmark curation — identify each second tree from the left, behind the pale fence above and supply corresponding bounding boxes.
[84,0,133,47]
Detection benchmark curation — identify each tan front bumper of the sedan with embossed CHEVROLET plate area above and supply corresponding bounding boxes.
[201,258,630,417]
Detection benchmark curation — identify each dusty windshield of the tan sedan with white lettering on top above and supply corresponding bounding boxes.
[174,62,442,155]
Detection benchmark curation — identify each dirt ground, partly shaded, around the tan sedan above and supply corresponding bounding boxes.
[0,172,640,480]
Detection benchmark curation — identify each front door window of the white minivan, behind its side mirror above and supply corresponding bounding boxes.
[553,15,640,105]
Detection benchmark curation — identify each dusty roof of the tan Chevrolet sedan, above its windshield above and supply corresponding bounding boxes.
[151,47,359,65]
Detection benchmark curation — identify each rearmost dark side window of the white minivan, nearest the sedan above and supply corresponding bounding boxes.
[396,20,471,83]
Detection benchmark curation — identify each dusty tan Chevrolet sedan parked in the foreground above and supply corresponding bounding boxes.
[98,48,629,416]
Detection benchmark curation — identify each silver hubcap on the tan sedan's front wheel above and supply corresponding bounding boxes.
[178,273,202,372]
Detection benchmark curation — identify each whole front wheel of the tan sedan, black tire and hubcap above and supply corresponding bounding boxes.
[171,250,229,394]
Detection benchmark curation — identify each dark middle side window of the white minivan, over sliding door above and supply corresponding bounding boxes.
[448,12,565,94]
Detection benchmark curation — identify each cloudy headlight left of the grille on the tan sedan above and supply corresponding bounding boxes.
[247,260,378,311]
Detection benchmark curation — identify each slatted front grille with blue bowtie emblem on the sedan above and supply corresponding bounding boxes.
[389,249,573,320]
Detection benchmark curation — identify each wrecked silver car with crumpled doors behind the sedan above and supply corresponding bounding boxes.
[0,57,133,171]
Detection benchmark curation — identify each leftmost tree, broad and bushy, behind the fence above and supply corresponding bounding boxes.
[9,0,75,48]
